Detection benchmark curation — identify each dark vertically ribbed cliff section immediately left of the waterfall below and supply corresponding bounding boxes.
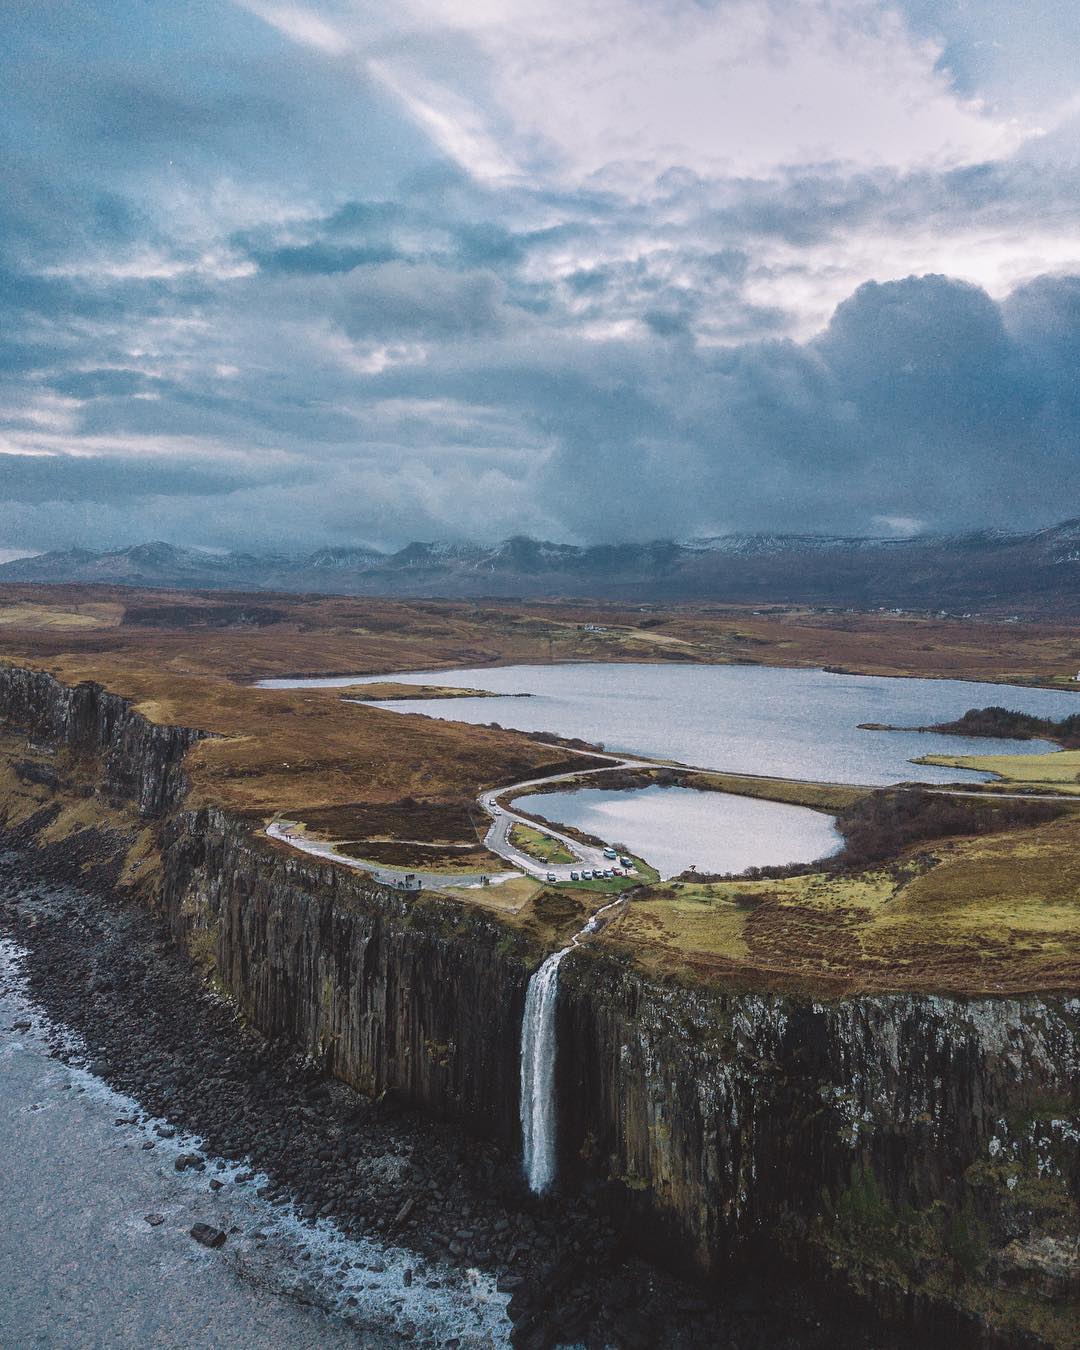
[162,810,528,1142]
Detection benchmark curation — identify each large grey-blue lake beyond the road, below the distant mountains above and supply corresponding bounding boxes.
[263,663,1080,786]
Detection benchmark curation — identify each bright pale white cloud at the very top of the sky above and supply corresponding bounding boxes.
[382,0,1029,190]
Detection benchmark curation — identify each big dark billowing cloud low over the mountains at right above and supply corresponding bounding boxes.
[534,277,1080,535]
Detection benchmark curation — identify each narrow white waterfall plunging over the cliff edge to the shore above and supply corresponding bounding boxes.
[521,899,624,1195]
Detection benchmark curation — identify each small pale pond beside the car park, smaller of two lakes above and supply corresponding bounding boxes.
[513,787,844,879]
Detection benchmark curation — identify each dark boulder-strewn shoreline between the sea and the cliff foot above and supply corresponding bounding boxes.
[0,838,902,1350]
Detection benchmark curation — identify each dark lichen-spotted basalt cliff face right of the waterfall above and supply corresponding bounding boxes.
[559,953,1080,1328]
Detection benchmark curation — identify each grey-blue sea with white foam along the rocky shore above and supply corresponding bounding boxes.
[0,934,509,1350]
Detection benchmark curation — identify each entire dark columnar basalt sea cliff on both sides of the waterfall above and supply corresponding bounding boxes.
[0,667,1080,1347]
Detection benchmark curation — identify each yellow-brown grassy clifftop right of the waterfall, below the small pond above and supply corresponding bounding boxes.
[608,814,1080,995]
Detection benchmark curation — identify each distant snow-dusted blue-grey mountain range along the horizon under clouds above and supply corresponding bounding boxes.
[0,520,1080,617]
